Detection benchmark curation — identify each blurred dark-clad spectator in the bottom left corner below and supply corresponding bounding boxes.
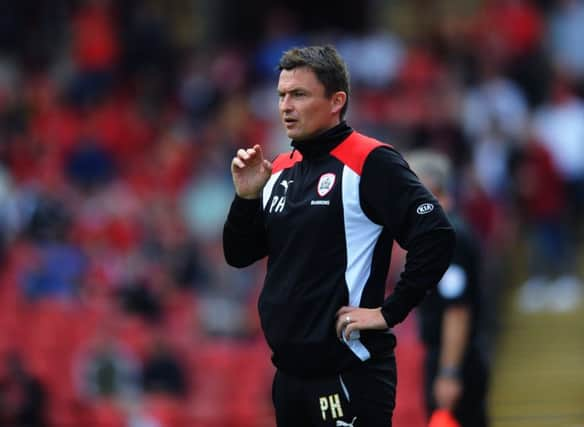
[0,353,47,427]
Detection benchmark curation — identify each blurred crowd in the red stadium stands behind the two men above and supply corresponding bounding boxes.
[0,0,584,427]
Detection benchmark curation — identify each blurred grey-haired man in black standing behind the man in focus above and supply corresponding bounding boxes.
[406,150,488,427]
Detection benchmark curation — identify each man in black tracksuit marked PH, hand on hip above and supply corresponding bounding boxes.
[223,46,454,427]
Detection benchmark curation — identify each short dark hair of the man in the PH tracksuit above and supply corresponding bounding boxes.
[278,45,350,119]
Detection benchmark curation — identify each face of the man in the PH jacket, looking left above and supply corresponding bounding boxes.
[278,67,342,140]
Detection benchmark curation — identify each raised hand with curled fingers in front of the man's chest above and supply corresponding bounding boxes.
[231,144,272,199]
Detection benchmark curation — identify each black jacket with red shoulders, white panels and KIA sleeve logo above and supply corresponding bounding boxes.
[223,122,454,377]
